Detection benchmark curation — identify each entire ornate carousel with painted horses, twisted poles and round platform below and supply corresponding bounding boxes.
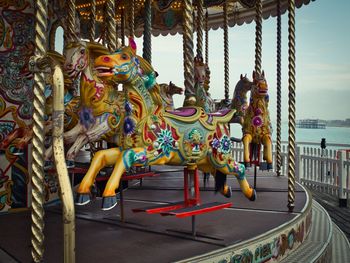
[0,0,340,262]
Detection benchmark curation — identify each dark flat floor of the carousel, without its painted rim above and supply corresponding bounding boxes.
[0,167,306,263]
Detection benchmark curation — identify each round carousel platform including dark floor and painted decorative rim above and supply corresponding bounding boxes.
[0,167,350,262]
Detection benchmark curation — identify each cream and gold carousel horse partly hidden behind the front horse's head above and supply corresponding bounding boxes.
[45,41,119,167]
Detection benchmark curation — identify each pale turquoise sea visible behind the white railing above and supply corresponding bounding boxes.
[231,123,350,149]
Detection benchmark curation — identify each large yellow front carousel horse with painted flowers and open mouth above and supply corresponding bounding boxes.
[76,41,256,210]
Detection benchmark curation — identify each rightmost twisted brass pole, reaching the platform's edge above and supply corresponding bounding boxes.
[288,0,295,212]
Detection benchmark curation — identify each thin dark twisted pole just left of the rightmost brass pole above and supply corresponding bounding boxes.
[276,0,282,176]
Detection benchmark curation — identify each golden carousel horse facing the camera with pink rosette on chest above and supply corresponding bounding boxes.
[242,71,272,169]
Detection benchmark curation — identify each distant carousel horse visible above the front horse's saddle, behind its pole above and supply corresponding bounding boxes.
[194,56,214,113]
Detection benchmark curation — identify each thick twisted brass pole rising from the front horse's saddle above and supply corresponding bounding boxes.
[182,0,196,106]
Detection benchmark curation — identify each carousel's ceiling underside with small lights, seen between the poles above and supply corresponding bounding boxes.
[76,0,315,37]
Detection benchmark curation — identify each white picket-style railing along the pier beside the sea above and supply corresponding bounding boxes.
[233,142,350,206]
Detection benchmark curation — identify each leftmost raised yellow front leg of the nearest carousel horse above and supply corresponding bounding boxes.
[76,148,120,205]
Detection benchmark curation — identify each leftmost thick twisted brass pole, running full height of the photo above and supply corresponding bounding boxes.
[31,0,48,262]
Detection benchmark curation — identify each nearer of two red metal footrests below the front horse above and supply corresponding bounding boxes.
[160,202,232,220]
